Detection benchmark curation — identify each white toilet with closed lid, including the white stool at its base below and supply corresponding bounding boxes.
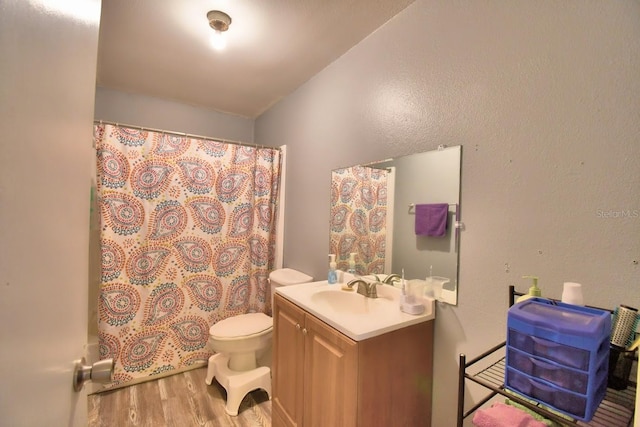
[205,268,313,416]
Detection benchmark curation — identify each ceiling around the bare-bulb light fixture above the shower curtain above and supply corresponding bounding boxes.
[97,0,413,118]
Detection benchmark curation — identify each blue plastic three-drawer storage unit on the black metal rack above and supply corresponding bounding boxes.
[505,298,611,421]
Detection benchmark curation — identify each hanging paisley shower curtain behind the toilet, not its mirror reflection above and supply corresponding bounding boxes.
[94,124,280,386]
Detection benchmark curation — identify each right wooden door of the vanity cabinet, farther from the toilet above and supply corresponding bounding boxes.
[303,314,358,427]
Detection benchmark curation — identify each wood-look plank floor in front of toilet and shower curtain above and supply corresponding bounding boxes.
[88,367,271,427]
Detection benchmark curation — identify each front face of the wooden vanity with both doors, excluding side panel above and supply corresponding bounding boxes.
[272,295,357,427]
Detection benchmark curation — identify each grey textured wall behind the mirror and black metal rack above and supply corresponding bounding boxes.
[255,0,640,427]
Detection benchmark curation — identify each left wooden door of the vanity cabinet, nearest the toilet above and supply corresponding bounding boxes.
[271,294,305,427]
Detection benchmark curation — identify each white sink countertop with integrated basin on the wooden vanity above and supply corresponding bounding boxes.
[276,280,435,341]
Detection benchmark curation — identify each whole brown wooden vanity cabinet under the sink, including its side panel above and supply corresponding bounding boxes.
[272,294,433,427]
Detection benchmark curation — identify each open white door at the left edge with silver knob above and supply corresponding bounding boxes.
[0,0,100,426]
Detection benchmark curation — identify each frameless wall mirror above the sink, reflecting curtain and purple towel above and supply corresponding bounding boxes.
[329,146,462,305]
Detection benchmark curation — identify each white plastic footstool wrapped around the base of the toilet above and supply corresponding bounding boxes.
[205,353,271,417]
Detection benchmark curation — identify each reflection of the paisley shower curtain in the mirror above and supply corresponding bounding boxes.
[329,166,388,275]
